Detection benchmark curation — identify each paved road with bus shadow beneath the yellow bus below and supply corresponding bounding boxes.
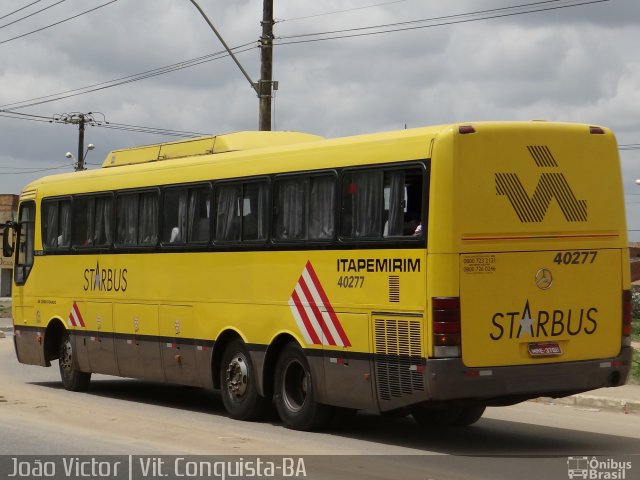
[0,335,640,480]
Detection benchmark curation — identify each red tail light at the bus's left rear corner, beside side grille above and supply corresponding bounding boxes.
[431,297,461,358]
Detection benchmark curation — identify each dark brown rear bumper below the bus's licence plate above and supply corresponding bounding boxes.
[425,347,632,405]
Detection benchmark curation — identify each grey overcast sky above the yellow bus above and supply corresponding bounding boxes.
[0,0,640,240]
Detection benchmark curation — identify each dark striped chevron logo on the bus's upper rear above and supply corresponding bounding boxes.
[496,145,587,223]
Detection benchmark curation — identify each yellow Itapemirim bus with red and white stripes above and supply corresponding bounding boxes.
[3,122,631,430]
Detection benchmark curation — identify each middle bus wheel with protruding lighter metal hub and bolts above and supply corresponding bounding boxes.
[220,340,268,420]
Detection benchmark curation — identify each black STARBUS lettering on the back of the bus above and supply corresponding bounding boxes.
[489,300,598,341]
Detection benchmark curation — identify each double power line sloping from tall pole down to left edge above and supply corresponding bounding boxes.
[0,42,258,112]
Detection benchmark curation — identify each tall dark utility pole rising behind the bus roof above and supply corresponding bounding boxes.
[258,0,273,131]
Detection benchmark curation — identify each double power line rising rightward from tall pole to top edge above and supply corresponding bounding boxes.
[276,0,611,45]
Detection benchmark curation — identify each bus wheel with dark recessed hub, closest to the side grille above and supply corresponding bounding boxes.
[274,343,331,430]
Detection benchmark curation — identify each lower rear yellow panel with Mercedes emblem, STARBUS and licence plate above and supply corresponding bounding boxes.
[460,249,622,367]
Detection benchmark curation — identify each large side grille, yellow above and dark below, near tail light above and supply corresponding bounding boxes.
[375,319,424,400]
